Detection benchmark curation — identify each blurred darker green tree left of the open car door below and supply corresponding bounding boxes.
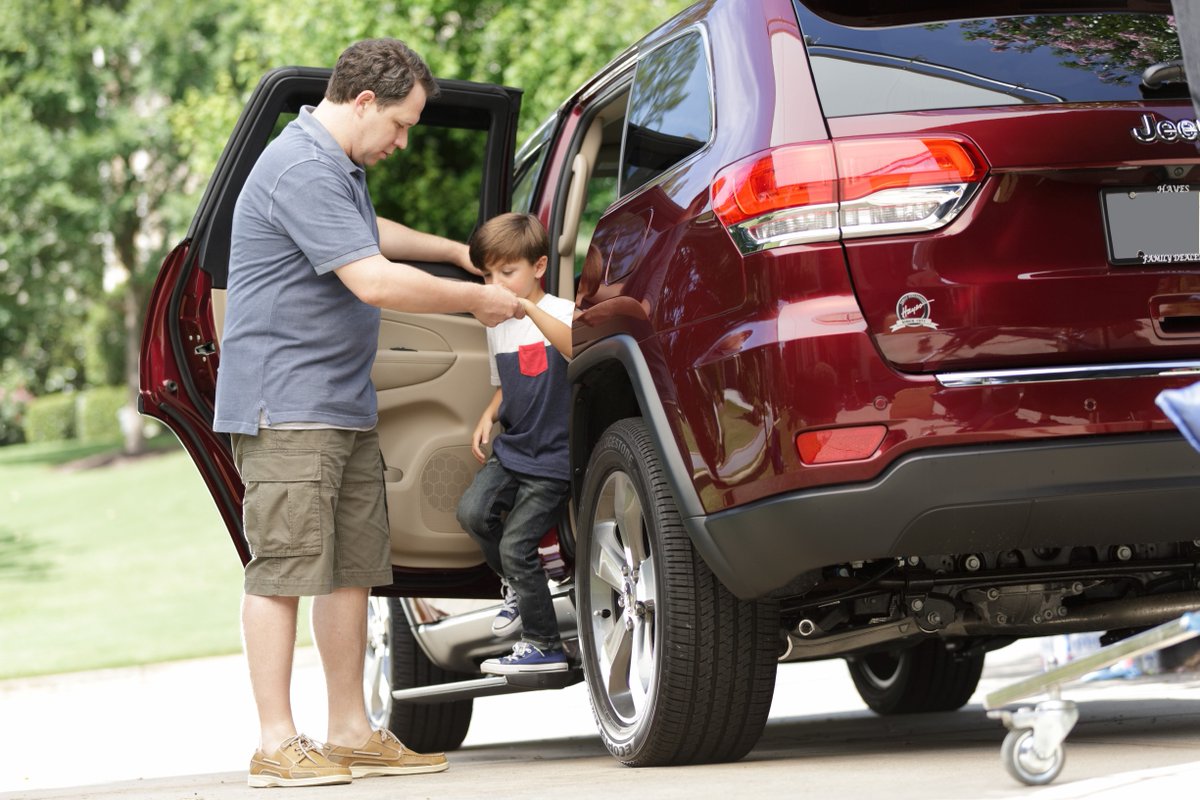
[0,0,259,452]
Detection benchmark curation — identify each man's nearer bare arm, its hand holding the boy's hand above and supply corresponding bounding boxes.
[334,255,524,326]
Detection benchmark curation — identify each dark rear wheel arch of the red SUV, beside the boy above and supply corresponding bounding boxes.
[568,333,752,600]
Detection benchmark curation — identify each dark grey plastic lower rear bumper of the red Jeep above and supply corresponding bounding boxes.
[686,433,1200,599]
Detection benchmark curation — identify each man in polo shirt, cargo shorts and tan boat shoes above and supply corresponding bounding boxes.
[212,40,521,787]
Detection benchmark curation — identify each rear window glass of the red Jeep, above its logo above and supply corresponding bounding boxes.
[797,2,1188,116]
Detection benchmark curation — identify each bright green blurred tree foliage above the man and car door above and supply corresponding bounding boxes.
[173,0,690,189]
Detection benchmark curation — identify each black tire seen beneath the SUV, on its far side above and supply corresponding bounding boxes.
[846,639,984,715]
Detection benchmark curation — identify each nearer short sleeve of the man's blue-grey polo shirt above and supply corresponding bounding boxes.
[269,158,379,275]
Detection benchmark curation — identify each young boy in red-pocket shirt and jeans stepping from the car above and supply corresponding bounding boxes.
[458,213,575,674]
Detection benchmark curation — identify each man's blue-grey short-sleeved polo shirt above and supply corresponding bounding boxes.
[212,108,379,434]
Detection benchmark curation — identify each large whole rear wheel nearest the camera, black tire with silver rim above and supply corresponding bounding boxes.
[575,419,779,766]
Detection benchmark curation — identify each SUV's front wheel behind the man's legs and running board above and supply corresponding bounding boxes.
[362,597,478,753]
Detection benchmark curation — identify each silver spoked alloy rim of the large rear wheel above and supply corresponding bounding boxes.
[588,471,658,724]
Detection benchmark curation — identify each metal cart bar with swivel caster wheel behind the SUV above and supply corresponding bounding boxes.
[984,612,1200,786]
